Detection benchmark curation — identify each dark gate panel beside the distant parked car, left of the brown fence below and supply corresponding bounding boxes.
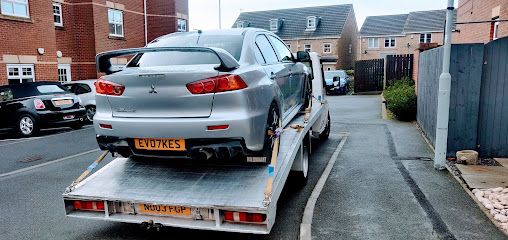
[355,59,385,93]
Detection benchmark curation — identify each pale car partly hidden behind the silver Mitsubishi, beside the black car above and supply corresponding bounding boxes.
[64,80,96,122]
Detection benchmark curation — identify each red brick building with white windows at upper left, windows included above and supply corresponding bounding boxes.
[0,0,188,85]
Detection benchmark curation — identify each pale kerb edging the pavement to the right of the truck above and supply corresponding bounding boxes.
[300,133,349,240]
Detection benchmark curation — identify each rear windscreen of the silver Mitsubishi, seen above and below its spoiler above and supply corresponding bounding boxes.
[127,34,243,67]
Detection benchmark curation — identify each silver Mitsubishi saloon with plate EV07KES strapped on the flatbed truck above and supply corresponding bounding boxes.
[94,28,310,162]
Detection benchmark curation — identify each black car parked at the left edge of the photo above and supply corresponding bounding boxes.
[0,82,86,136]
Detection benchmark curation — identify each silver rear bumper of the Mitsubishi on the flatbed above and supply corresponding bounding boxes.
[94,109,267,154]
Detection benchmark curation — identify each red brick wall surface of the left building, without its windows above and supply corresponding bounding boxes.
[0,0,188,85]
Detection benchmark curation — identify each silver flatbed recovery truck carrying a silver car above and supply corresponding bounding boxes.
[63,53,330,234]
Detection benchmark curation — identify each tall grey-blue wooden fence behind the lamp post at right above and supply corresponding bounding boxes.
[417,38,508,157]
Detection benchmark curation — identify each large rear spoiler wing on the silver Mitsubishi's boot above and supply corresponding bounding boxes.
[95,47,240,74]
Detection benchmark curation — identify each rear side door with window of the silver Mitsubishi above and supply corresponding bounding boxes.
[256,34,291,114]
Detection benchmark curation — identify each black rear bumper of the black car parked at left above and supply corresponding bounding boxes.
[37,108,86,128]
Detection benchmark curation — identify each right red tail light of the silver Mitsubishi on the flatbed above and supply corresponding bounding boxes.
[187,74,247,94]
